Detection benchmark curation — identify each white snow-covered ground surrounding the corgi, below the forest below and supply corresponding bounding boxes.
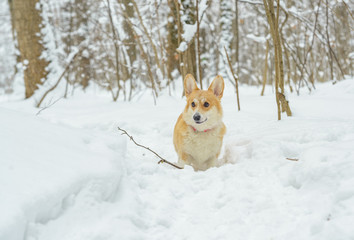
[0,80,354,240]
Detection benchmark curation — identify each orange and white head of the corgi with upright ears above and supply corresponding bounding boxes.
[183,74,224,131]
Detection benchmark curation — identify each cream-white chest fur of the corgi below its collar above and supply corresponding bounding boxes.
[183,127,222,169]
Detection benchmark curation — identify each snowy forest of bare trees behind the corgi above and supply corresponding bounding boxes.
[0,0,354,111]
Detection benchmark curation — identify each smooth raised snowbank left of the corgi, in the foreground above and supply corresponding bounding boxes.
[0,108,125,239]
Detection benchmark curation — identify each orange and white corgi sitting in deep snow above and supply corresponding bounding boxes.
[173,74,226,171]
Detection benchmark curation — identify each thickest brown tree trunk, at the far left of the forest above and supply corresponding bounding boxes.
[9,0,48,98]
